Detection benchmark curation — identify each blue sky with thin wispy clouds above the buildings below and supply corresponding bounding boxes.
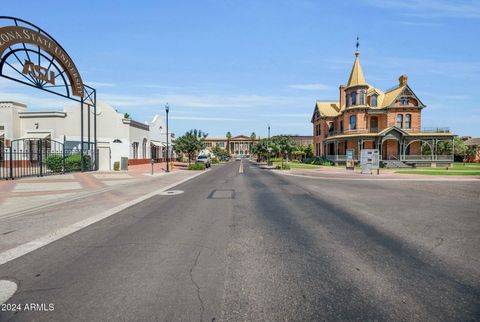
[0,0,480,136]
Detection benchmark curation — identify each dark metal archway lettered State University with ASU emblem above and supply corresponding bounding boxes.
[0,16,98,177]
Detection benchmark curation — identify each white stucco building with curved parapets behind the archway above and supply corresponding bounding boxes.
[0,102,173,170]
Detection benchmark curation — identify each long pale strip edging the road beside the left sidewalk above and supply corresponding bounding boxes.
[0,171,208,265]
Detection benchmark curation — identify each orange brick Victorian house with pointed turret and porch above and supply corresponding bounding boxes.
[311,48,453,169]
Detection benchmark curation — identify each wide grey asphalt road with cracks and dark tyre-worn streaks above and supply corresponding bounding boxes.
[0,161,480,321]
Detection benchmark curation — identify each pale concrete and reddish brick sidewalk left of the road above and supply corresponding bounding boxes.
[0,170,204,253]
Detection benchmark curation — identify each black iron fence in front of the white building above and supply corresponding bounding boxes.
[0,138,95,179]
